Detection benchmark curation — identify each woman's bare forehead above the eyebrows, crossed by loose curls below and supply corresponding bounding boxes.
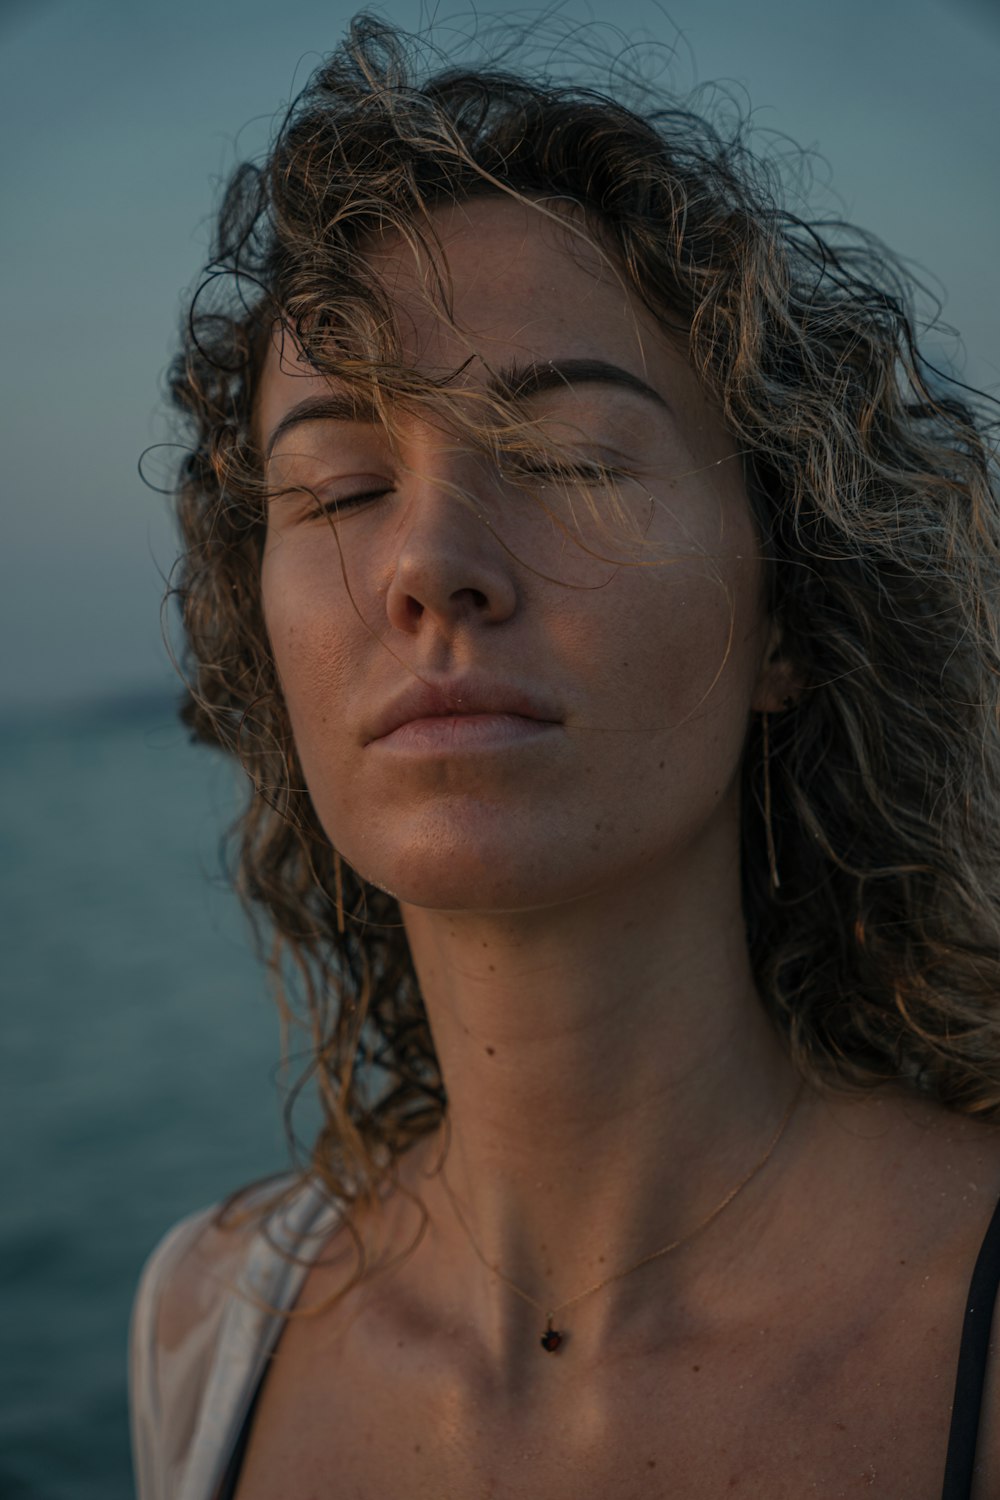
[258,195,732,468]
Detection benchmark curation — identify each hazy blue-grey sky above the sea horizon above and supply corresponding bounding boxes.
[0,0,1000,710]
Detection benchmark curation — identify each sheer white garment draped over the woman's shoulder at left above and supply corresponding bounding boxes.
[129,1178,337,1500]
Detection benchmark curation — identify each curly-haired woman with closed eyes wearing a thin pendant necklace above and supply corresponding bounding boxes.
[132,17,1000,1500]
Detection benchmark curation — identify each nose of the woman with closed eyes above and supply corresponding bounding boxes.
[385,471,519,635]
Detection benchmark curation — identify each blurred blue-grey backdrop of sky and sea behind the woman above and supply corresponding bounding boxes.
[0,0,1000,1500]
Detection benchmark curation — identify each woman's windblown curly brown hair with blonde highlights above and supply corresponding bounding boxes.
[171,14,1000,1248]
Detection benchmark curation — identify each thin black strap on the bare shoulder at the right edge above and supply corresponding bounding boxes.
[942,1203,1000,1500]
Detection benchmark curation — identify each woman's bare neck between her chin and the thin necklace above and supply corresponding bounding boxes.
[395,816,795,1356]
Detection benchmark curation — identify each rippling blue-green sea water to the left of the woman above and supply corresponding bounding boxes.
[0,699,301,1500]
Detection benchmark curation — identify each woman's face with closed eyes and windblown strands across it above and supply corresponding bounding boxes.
[258,198,787,911]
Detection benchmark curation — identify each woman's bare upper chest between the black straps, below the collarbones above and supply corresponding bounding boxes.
[229,1278,993,1500]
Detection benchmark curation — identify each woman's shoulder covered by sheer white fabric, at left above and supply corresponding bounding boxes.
[129,1176,328,1500]
